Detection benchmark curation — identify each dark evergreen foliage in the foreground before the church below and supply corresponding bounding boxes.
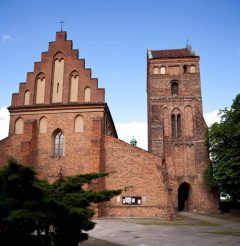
[0,160,121,246]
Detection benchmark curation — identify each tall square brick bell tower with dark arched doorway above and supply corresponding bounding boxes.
[147,45,218,211]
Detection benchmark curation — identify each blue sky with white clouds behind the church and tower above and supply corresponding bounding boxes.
[0,0,240,149]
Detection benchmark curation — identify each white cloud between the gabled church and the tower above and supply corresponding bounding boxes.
[116,122,148,150]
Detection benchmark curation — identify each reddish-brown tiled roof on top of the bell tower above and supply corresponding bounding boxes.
[148,47,197,59]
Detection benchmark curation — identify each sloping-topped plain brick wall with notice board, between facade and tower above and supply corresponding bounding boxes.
[103,136,173,217]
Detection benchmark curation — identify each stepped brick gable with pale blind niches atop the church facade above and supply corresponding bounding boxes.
[9,32,105,110]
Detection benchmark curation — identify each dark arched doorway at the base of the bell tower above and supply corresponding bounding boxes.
[178,182,191,211]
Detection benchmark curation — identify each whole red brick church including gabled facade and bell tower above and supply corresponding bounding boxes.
[0,32,218,218]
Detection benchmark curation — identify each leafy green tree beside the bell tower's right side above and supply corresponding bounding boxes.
[205,94,240,198]
